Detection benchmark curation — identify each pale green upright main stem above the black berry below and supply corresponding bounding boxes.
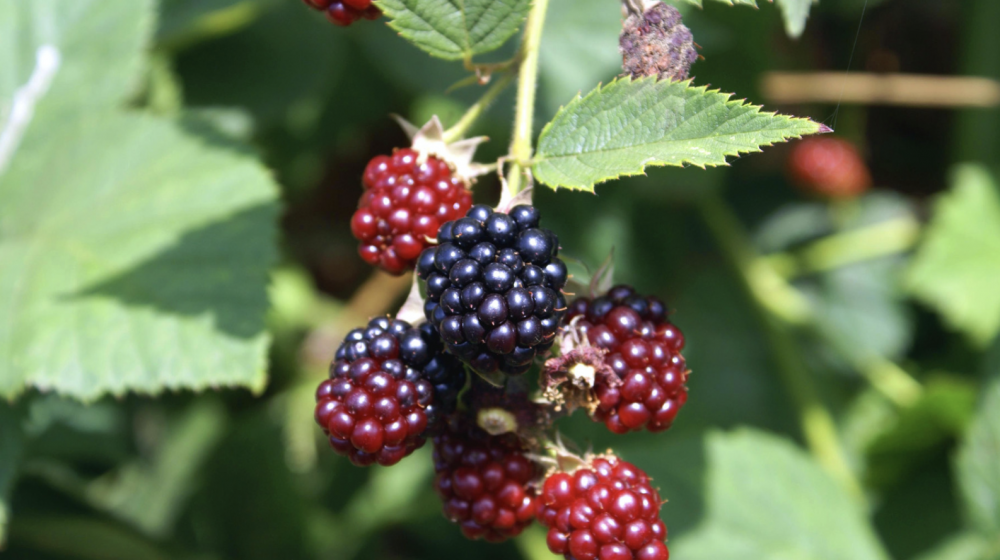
[507,0,549,195]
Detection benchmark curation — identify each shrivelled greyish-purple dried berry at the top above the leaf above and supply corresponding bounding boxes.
[618,2,698,80]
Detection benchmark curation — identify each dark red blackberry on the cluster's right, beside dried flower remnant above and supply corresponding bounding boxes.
[568,286,688,434]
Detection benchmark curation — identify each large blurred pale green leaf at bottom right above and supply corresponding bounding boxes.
[671,430,887,560]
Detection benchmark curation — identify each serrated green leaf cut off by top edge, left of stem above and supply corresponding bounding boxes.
[375,0,531,60]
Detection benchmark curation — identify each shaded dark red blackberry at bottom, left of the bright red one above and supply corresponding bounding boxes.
[434,426,541,542]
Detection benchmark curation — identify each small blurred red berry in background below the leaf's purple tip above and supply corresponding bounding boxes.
[788,136,872,198]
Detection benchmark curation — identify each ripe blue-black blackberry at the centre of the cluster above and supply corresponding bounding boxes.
[417,205,568,375]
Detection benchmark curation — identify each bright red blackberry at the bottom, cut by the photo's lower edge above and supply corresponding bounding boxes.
[538,455,670,560]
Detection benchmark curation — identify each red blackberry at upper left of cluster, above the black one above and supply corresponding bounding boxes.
[351,148,472,274]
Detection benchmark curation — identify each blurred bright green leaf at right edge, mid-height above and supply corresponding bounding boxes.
[906,164,1000,347]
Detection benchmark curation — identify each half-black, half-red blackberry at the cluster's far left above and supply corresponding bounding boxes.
[315,317,465,466]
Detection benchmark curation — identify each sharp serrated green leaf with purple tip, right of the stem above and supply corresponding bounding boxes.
[534,77,825,191]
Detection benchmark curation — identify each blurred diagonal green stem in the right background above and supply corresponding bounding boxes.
[700,196,863,499]
